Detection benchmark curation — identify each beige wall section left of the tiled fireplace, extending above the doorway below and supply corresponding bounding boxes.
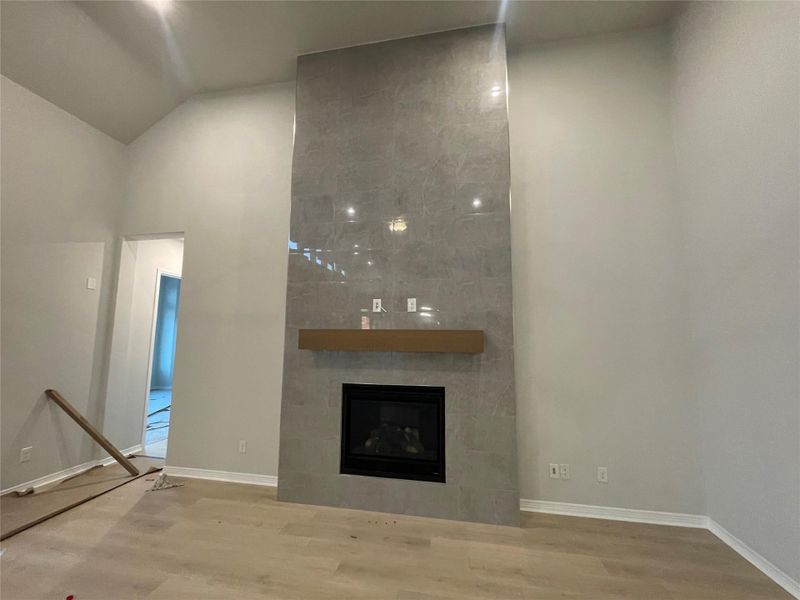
[123,83,294,475]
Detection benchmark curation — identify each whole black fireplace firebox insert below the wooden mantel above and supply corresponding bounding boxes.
[340,383,445,483]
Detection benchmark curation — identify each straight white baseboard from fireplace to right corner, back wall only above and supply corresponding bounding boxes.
[519,498,708,529]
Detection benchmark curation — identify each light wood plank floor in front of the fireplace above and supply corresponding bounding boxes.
[0,478,789,600]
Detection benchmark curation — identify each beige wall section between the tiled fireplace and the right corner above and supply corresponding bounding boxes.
[509,29,704,513]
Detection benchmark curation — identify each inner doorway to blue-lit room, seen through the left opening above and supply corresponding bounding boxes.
[143,268,181,458]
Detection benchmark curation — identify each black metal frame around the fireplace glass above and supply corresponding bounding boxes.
[339,383,447,483]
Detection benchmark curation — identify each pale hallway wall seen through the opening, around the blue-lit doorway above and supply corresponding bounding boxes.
[103,239,183,448]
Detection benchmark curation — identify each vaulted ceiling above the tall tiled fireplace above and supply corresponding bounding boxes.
[0,0,676,143]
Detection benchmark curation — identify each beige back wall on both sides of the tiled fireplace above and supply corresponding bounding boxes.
[124,30,704,513]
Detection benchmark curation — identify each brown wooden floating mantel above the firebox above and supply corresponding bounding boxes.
[297,329,483,354]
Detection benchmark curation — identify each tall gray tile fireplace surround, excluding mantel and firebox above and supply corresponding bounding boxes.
[278,26,519,525]
